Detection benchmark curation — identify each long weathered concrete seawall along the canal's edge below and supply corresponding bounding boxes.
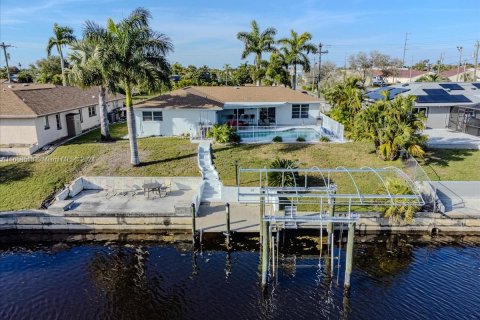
[0,206,480,234]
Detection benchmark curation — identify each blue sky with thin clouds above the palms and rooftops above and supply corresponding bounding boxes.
[0,0,480,67]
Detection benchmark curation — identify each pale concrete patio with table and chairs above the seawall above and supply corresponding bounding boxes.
[48,177,203,217]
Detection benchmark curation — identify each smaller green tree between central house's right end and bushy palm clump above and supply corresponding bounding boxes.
[323,77,364,131]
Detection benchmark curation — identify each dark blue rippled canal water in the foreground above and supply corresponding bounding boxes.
[0,234,480,320]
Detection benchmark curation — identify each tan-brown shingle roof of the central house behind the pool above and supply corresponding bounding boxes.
[135,86,320,109]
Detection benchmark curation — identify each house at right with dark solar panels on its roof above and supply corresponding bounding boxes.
[367,82,480,132]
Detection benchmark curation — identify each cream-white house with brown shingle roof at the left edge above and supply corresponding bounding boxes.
[0,83,124,155]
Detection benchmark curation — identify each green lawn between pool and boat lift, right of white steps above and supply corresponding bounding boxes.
[214,143,402,198]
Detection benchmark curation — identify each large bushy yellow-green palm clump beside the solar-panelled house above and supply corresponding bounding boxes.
[353,93,426,160]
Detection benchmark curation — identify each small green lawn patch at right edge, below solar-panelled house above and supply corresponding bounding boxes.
[419,149,480,181]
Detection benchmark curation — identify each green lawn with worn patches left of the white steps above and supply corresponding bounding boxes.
[0,124,199,211]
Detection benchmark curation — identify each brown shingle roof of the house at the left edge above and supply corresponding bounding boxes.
[0,84,124,118]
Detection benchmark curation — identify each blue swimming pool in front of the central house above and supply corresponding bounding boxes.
[237,128,322,142]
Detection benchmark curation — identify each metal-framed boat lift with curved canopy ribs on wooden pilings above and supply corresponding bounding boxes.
[237,167,425,289]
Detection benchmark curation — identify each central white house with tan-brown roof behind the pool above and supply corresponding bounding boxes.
[134,86,320,137]
